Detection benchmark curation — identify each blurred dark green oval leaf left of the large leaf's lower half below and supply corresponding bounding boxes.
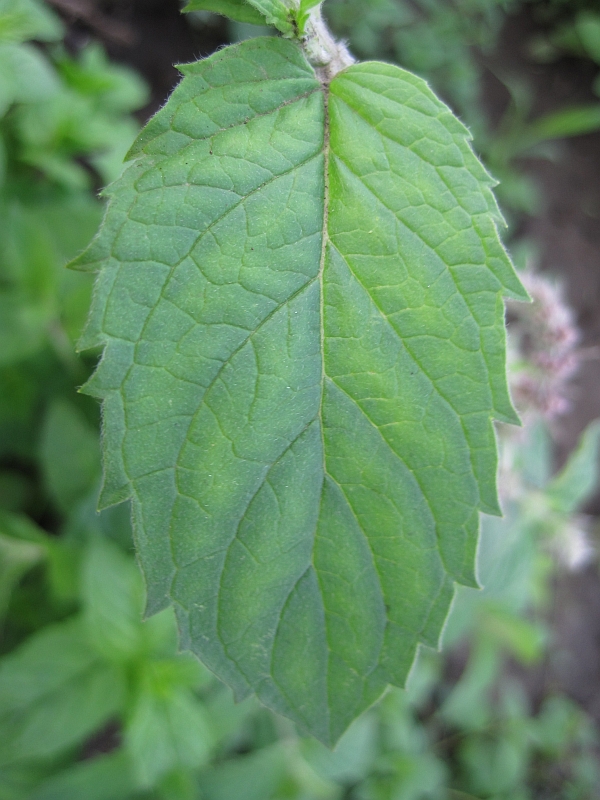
[40,400,100,513]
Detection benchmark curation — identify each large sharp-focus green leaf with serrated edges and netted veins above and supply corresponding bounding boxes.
[78,34,525,743]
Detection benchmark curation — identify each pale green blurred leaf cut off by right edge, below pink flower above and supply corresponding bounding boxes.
[546,420,600,514]
